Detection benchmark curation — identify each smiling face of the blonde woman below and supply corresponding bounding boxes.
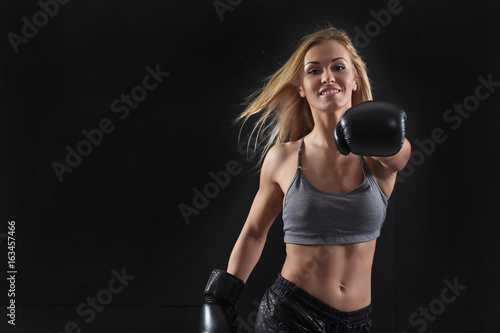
[297,40,358,112]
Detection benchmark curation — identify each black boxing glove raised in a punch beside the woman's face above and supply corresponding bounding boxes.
[334,101,406,157]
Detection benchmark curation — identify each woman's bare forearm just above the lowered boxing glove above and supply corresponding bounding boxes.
[227,228,266,283]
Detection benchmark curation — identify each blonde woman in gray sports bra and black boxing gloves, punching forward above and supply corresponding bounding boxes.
[200,27,411,333]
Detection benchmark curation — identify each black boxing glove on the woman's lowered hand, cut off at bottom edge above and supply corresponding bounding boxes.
[200,269,245,333]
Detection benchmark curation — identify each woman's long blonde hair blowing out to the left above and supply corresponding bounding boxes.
[235,25,372,164]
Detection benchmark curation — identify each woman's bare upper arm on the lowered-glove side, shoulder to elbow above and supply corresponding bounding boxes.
[244,146,284,239]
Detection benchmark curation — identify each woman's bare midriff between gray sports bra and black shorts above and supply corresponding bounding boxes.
[281,240,376,312]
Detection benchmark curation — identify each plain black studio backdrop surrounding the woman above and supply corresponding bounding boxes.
[0,0,500,333]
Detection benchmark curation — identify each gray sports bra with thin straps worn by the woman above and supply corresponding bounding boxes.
[282,138,387,245]
